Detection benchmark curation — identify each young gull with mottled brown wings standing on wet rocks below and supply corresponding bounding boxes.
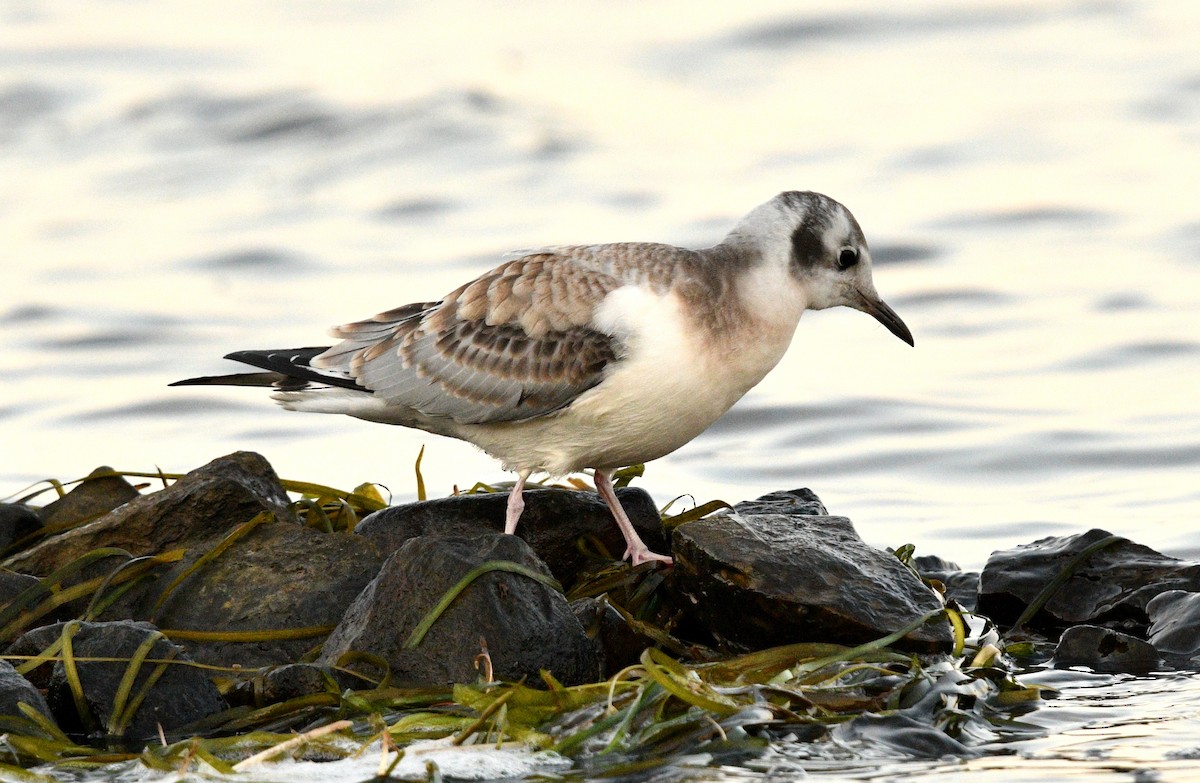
[172,191,913,566]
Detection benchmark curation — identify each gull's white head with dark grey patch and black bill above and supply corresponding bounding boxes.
[734,191,913,345]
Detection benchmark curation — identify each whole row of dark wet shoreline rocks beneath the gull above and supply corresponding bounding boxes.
[0,453,1200,742]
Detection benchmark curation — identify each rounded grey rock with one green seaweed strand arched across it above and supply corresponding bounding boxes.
[318,531,600,685]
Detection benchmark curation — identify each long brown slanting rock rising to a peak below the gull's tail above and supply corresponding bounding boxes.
[4,452,295,575]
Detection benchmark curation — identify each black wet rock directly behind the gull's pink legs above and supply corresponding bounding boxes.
[354,486,667,586]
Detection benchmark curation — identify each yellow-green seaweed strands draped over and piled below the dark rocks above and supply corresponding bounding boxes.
[0,455,1044,782]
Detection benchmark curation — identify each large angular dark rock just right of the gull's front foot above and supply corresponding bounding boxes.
[673,492,950,652]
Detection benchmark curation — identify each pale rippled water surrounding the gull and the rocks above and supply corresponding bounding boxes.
[0,0,1200,779]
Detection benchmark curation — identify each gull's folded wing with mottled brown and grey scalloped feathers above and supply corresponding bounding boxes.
[312,246,667,424]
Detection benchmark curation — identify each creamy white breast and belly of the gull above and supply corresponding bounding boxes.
[460,286,803,474]
